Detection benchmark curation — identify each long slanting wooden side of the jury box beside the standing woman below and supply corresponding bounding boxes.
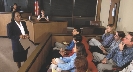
[18,33,52,72]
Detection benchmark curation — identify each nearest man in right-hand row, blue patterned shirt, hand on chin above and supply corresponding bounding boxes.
[97,32,133,72]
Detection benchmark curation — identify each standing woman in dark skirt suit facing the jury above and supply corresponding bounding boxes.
[7,11,29,68]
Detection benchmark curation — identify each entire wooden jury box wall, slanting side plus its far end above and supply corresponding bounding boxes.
[18,33,101,72]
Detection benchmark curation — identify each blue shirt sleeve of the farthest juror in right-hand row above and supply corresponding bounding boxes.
[102,34,114,46]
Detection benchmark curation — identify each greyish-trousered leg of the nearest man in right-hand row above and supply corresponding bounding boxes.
[97,63,113,72]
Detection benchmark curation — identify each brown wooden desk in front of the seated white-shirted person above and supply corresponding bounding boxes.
[26,21,67,43]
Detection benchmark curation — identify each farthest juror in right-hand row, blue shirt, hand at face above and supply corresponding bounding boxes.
[89,24,115,53]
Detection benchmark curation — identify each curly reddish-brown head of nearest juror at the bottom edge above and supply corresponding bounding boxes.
[74,56,89,72]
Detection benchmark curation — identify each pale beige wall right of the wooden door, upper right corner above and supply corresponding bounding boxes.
[117,0,133,32]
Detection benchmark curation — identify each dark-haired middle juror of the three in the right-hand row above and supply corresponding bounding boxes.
[93,31,125,55]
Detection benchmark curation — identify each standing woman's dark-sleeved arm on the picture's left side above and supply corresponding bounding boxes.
[7,23,20,39]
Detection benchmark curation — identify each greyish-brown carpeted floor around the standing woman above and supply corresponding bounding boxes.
[0,37,36,72]
